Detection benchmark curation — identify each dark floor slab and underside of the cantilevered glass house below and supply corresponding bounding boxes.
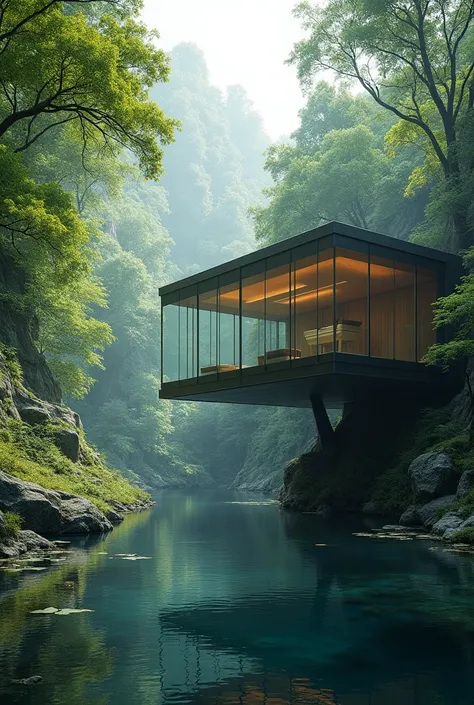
[160,353,463,408]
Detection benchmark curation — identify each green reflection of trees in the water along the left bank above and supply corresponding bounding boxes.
[0,513,152,705]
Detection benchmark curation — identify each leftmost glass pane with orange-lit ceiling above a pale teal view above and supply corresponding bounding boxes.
[217,272,240,373]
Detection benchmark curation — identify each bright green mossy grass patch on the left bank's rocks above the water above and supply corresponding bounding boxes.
[0,421,147,511]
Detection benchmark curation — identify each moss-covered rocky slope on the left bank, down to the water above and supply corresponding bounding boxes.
[0,286,150,555]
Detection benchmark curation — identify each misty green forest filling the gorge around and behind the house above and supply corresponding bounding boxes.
[0,0,474,500]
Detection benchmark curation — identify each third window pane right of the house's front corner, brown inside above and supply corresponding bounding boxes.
[394,262,415,362]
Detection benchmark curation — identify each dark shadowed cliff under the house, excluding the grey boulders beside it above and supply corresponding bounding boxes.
[280,372,474,516]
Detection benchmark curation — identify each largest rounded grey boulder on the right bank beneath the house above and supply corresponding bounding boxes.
[408,453,456,502]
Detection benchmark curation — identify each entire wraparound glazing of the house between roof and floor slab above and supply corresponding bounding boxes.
[162,238,441,381]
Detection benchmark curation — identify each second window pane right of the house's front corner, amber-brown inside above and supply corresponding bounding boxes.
[370,255,395,359]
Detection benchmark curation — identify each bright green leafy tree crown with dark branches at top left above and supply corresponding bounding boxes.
[0,0,177,177]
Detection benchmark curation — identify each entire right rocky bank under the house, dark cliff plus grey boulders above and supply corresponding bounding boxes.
[280,363,474,538]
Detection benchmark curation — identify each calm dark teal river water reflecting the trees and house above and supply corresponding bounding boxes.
[0,492,474,705]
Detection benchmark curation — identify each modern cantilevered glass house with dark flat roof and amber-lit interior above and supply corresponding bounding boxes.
[160,223,461,407]
